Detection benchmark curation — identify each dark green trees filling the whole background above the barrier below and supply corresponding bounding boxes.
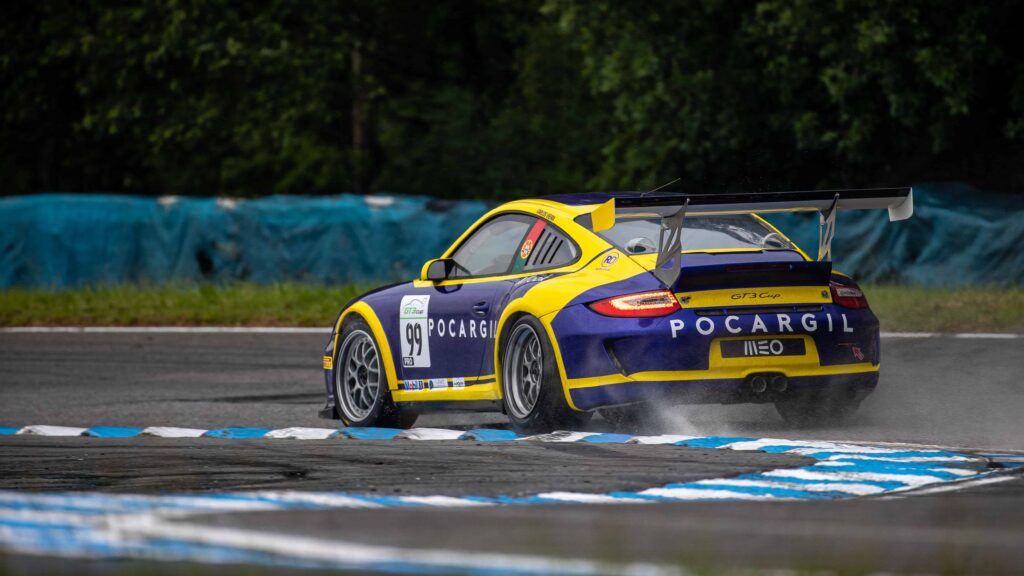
[0,0,1024,198]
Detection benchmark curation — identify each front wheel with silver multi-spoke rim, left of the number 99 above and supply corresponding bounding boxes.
[334,316,417,428]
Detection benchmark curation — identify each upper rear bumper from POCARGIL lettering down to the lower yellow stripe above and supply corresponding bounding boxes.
[550,304,881,381]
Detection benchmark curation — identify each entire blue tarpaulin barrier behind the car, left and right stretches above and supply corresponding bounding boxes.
[0,184,1024,288]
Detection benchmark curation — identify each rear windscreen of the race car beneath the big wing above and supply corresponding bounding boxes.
[580,206,794,254]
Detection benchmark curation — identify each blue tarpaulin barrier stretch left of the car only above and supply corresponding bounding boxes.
[0,195,489,288]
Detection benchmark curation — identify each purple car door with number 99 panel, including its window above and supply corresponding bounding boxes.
[399,213,537,389]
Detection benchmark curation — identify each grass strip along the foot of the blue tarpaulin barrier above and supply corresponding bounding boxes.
[0,284,1024,333]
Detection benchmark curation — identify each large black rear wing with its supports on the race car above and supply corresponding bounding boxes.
[592,188,913,286]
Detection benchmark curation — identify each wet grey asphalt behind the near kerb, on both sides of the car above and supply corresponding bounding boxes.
[0,333,1024,450]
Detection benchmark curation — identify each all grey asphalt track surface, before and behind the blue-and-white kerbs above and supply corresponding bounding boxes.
[0,333,1024,574]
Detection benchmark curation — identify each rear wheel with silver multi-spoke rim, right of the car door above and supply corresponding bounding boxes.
[502,316,592,434]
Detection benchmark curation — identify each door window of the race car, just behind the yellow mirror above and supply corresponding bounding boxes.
[452,214,537,278]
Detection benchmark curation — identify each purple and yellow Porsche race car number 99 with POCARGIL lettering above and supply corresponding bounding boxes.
[319,189,913,434]
